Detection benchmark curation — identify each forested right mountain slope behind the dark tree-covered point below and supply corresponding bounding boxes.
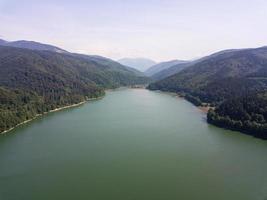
[149,47,267,103]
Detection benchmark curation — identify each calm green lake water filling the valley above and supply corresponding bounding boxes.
[0,89,267,200]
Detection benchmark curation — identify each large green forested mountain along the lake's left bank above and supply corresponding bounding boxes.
[0,46,151,132]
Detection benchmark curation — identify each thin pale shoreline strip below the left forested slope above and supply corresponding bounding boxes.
[0,95,105,135]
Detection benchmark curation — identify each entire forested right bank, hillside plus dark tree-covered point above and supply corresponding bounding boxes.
[148,47,267,138]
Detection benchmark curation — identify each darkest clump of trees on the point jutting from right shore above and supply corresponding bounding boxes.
[207,92,267,139]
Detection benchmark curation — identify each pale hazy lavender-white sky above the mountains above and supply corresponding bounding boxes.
[0,0,267,62]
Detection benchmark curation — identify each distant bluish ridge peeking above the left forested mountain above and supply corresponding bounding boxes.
[0,39,68,53]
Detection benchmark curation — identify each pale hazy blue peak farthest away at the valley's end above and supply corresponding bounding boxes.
[118,58,156,72]
